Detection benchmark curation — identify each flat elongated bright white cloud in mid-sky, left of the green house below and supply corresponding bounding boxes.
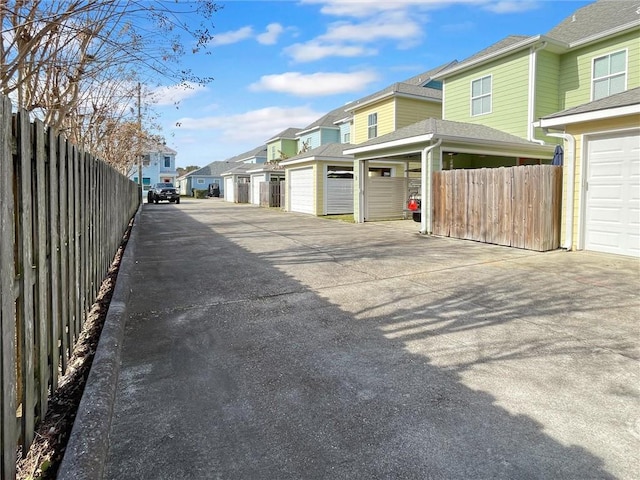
[249,71,378,97]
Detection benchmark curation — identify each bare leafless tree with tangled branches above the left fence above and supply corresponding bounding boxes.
[0,0,220,167]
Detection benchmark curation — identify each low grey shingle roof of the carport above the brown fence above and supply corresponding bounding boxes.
[352,118,548,150]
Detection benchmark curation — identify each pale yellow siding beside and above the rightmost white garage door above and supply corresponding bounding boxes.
[560,115,640,250]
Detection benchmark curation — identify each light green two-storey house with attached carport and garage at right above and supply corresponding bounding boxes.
[345,0,640,256]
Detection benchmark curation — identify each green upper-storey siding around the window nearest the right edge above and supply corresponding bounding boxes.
[558,30,640,110]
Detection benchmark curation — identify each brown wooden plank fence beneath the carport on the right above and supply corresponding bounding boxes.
[432,165,562,251]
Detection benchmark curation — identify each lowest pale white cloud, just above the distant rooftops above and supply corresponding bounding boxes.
[177,107,326,142]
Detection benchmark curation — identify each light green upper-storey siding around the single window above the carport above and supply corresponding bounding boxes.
[443,50,529,138]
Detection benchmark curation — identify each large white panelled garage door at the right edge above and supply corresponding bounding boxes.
[585,131,640,257]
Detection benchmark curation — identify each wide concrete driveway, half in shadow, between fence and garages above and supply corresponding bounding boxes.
[79,199,640,479]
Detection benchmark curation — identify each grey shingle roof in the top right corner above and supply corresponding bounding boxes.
[547,0,640,45]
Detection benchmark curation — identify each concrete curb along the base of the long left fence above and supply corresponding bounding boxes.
[57,205,142,480]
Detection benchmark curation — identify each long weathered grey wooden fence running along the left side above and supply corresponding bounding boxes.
[0,97,140,479]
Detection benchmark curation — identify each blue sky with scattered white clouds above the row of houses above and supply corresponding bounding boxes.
[150,0,591,167]
